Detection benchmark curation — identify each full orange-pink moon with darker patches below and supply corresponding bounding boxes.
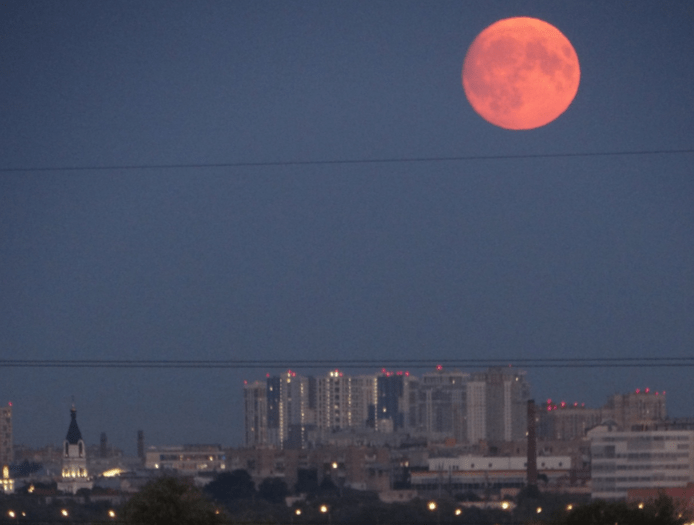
[462,17,581,129]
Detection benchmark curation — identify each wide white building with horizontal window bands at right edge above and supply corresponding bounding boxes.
[588,424,694,500]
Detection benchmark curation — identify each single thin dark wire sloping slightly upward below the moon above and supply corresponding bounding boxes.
[0,148,694,173]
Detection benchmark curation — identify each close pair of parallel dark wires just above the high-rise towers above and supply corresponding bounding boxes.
[0,357,694,369]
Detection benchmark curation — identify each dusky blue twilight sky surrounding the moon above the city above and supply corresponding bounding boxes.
[0,0,694,453]
